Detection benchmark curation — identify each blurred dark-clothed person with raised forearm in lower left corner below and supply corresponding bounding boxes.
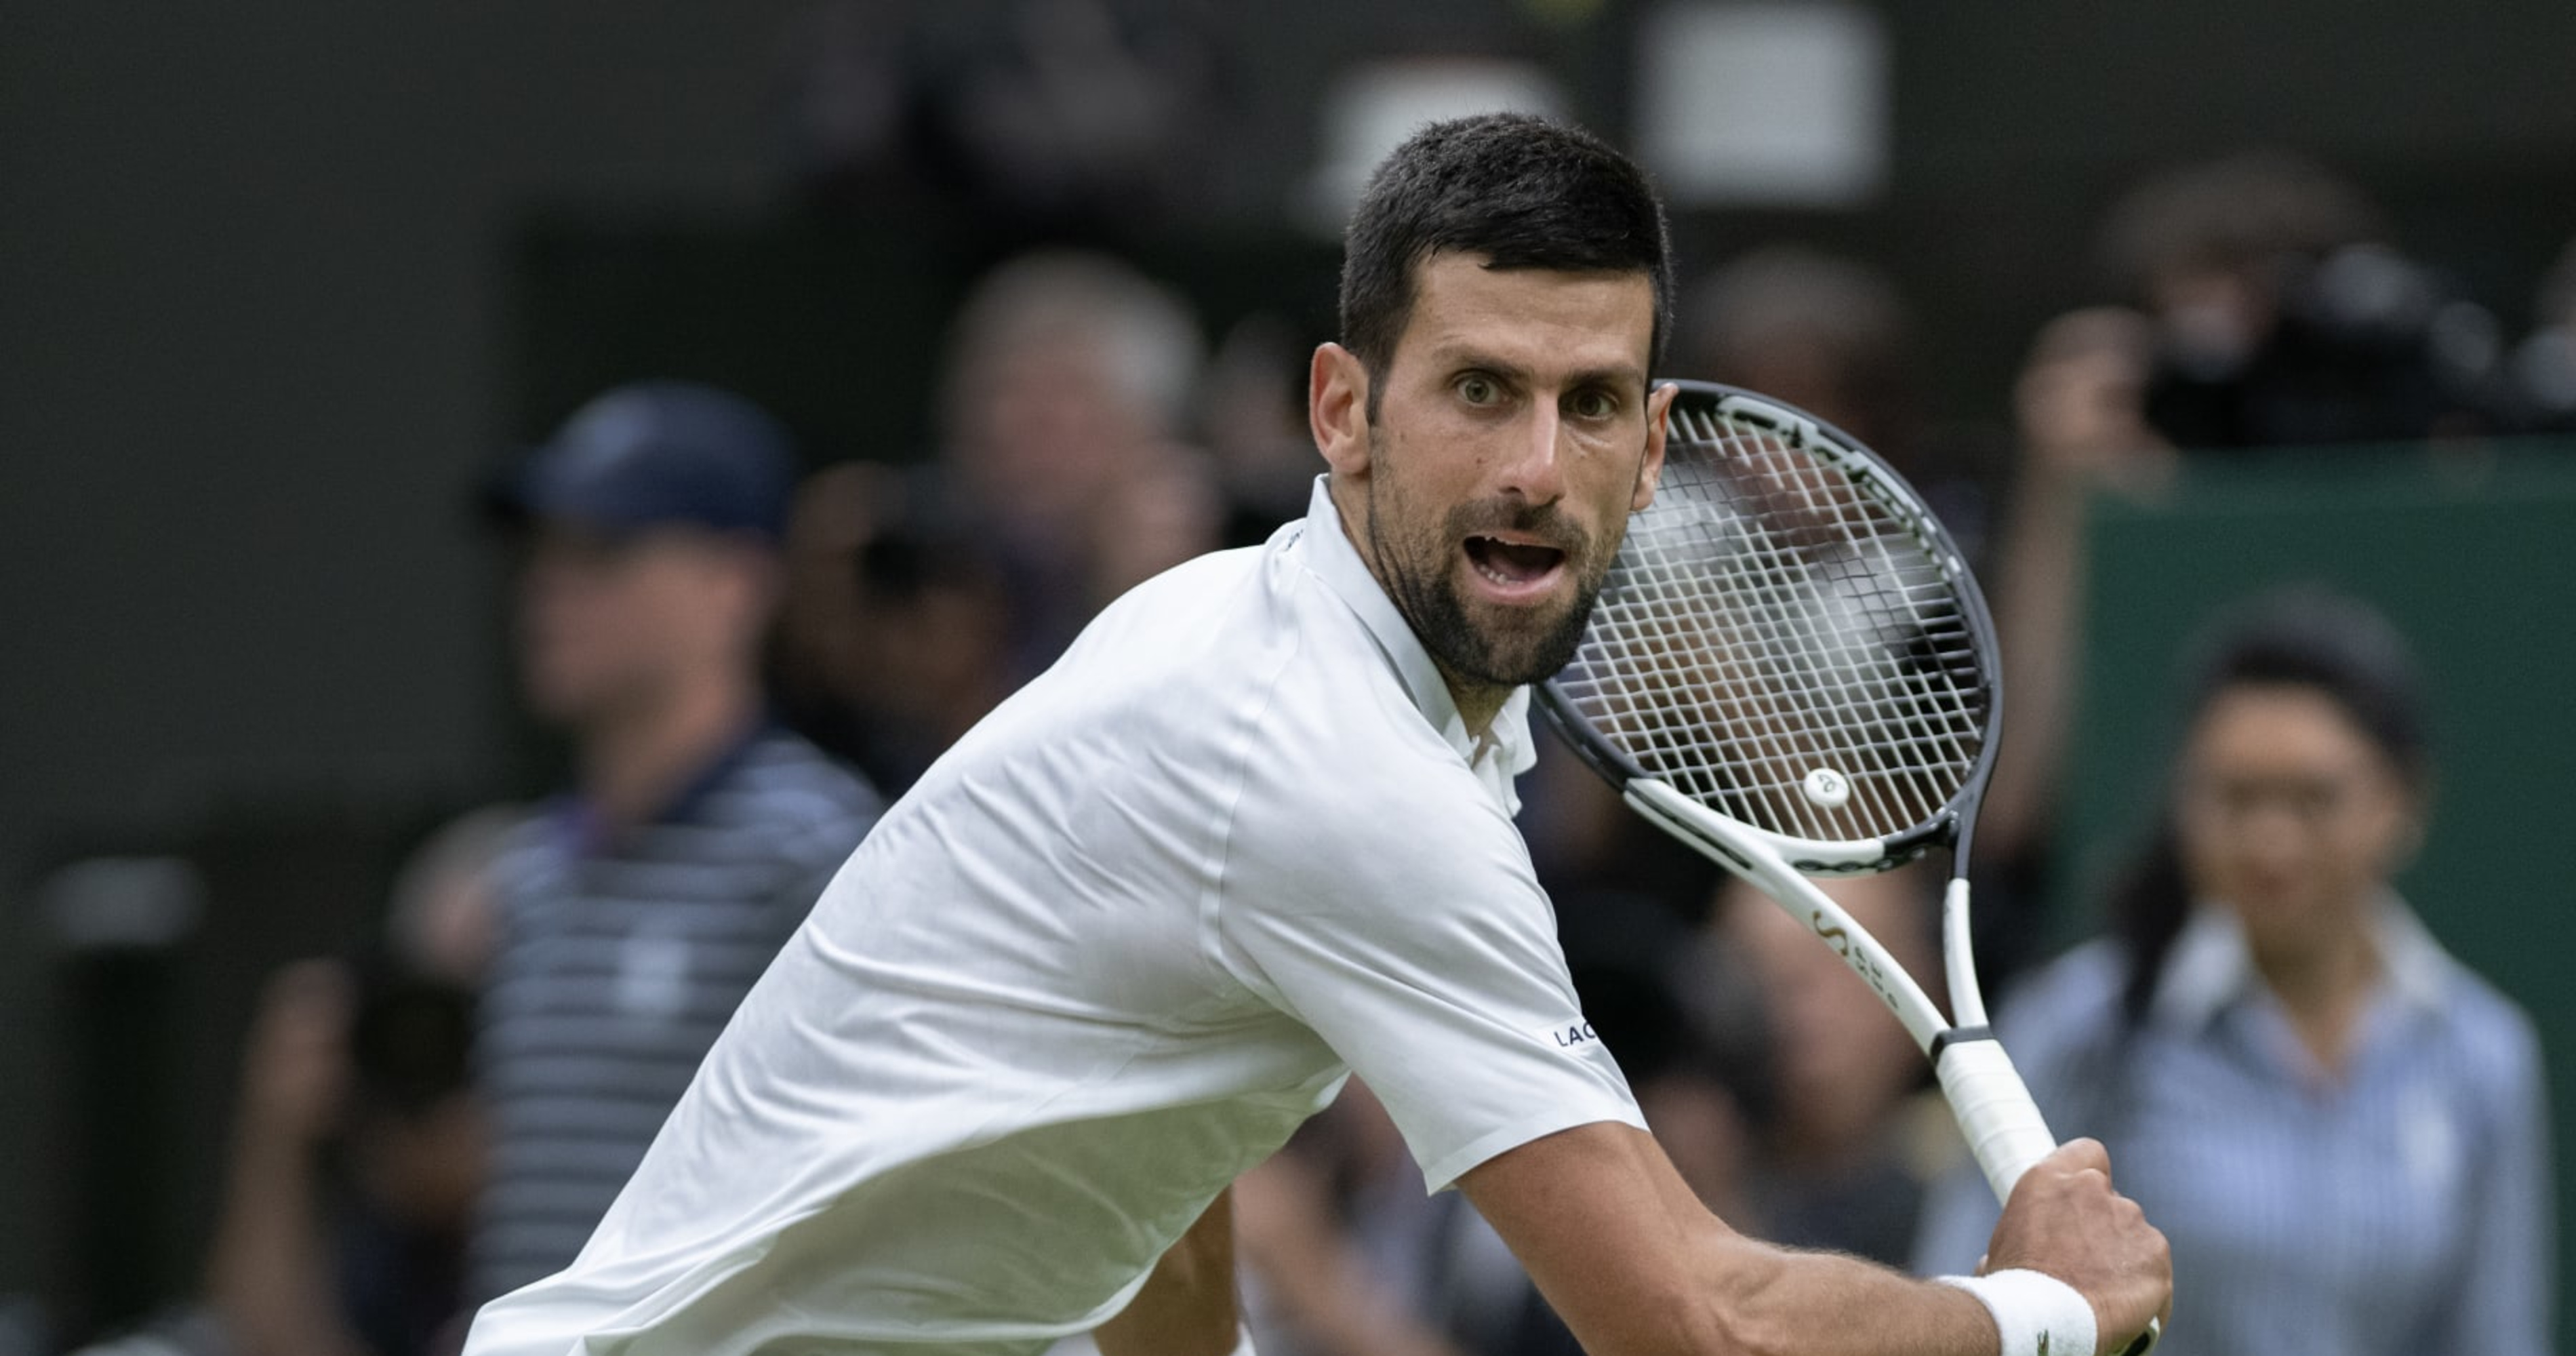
[74,961,484,1356]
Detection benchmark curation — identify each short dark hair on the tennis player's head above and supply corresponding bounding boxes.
[1342,113,1672,399]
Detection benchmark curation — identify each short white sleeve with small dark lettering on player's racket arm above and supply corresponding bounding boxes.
[1216,765,1643,1191]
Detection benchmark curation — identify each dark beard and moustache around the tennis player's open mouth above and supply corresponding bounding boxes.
[1368,464,1613,688]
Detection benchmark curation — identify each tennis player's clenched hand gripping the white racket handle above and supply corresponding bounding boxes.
[1986,1140,2174,1351]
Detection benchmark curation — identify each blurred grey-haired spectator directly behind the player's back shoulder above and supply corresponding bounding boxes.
[940,253,1221,685]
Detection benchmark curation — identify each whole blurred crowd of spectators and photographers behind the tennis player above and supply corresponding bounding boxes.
[45,5,2576,1356]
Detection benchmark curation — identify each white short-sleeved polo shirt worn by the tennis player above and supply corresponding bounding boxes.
[466,482,1643,1356]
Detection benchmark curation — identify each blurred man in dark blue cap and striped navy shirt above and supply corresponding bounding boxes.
[453,382,879,1302]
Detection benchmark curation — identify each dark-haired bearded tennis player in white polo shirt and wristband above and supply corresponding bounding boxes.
[466,116,2169,1356]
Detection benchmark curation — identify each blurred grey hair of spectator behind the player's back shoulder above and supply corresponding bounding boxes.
[943,250,1205,436]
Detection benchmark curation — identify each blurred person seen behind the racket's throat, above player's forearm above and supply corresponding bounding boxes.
[1718,869,1958,1266]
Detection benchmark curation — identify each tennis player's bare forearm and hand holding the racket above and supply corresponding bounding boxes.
[1458,1121,2171,1356]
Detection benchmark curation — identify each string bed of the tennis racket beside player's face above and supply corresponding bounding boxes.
[1558,407,1989,841]
